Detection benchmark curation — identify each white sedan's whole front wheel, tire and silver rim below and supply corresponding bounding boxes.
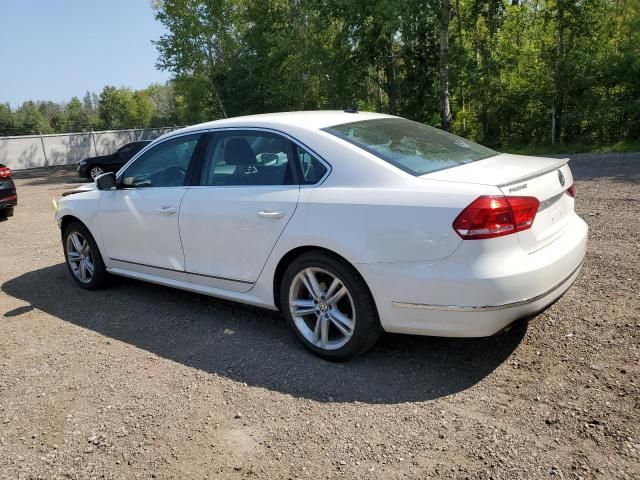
[62,222,107,290]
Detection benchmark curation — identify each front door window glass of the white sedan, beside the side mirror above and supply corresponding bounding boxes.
[122,134,200,187]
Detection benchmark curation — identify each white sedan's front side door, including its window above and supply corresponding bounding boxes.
[99,134,202,281]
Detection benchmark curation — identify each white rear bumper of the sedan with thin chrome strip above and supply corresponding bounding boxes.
[358,215,588,337]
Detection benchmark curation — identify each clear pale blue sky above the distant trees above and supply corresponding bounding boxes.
[0,0,170,108]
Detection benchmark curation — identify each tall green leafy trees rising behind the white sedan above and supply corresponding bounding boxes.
[154,0,640,146]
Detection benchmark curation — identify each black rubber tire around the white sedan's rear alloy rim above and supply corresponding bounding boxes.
[280,251,383,361]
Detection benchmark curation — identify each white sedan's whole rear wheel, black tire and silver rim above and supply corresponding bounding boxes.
[280,252,382,361]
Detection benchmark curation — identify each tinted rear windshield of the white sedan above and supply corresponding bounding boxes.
[324,118,498,176]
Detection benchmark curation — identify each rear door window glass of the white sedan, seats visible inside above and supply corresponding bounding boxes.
[200,132,293,186]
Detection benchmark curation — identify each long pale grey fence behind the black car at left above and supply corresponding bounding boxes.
[0,126,182,170]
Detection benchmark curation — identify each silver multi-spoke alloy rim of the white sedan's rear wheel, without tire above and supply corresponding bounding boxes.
[289,267,356,350]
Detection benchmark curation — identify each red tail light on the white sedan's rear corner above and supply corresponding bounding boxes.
[453,195,540,240]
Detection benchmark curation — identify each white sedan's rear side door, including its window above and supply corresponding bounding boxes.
[180,130,299,291]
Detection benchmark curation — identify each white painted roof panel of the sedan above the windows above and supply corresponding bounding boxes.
[175,110,392,132]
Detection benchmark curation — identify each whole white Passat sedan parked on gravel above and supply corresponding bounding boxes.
[54,111,587,360]
